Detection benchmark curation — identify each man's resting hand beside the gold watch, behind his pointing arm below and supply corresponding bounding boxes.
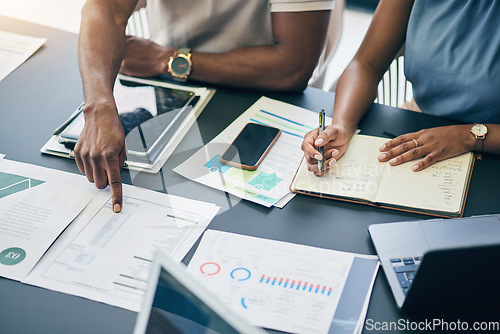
[120,36,175,77]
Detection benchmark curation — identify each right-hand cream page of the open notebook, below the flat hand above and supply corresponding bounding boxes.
[375,152,473,214]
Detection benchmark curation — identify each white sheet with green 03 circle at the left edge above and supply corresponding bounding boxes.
[0,159,97,280]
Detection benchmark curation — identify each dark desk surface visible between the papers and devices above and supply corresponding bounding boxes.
[0,16,500,333]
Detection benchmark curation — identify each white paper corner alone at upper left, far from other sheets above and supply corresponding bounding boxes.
[0,30,47,81]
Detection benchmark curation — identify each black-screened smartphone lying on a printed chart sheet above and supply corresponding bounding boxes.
[220,123,281,170]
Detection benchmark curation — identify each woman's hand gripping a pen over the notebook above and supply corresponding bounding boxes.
[301,125,352,176]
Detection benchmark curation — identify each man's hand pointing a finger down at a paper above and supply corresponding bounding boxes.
[75,106,126,212]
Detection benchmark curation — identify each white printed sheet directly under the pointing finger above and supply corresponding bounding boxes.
[25,185,219,311]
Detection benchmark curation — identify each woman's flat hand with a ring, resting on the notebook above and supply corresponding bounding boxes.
[378,125,475,172]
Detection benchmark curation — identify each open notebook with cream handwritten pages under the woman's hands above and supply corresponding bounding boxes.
[290,135,474,217]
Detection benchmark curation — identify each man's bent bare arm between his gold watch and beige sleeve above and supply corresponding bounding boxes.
[186,11,330,91]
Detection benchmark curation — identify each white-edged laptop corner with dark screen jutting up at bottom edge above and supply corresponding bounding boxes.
[134,252,266,334]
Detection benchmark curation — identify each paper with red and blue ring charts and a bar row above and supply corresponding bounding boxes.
[187,230,377,333]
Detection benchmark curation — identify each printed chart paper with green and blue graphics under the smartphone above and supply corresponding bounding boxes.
[174,97,326,207]
